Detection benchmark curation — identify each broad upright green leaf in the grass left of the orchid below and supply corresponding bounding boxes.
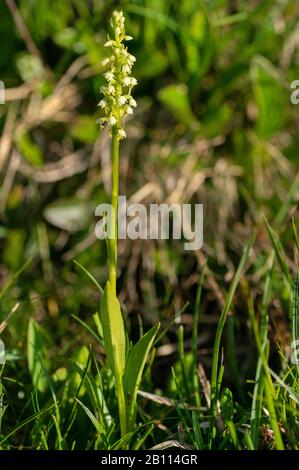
[27,318,49,392]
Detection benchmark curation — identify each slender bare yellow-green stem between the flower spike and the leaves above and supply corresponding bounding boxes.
[108,129,119,294]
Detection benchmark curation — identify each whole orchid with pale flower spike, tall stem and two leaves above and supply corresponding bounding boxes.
[99,11,159,437]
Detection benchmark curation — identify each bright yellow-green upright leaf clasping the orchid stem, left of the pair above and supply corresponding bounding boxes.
[101,281,126,379]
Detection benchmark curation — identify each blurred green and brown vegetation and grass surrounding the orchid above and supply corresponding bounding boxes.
[0,0,299,449]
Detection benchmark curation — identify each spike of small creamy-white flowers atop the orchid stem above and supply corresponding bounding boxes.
[98,11,137,139]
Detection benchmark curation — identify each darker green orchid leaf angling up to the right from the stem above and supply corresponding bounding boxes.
[123,323,160,401]
